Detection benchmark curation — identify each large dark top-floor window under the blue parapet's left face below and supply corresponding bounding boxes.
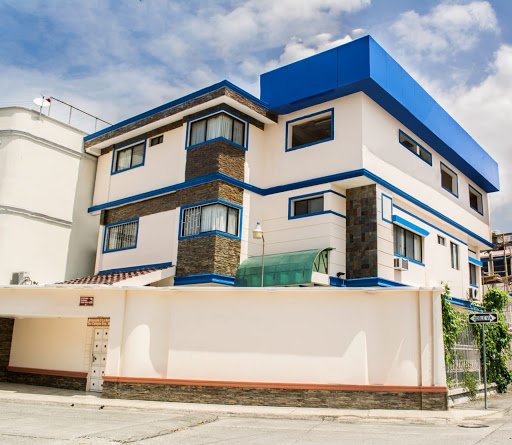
[286,110,334,151]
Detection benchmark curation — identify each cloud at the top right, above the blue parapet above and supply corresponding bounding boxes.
[391,1,499,61]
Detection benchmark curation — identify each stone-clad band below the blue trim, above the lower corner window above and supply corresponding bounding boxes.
[101,181,244,224]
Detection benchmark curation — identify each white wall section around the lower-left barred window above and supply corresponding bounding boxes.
[96,209,180,272]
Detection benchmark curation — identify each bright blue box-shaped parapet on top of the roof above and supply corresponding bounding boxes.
[260,36,500,192]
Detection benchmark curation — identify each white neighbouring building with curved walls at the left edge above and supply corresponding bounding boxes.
[0,107,99,284]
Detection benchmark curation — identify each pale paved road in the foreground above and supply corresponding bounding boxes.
[0,401,512,445]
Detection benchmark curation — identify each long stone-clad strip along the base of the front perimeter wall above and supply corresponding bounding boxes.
[103,382,448,410]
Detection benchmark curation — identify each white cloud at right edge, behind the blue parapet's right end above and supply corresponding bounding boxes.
[435,45,512,232]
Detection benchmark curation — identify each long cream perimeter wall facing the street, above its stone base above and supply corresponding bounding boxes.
[0,286,446,386]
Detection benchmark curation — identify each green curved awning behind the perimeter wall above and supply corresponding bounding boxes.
[235,247,332,287]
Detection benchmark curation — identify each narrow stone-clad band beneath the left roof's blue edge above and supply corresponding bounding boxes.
[84,87,277,149]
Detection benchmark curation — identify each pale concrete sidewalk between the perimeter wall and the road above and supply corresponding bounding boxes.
[0,383,506,425]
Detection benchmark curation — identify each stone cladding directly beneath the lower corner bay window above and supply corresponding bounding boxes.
[176,235,240,276]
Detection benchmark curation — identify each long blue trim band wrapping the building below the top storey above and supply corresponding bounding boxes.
[88,169,494,248]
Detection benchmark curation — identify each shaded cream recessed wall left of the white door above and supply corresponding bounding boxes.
[9,318,91,372]
